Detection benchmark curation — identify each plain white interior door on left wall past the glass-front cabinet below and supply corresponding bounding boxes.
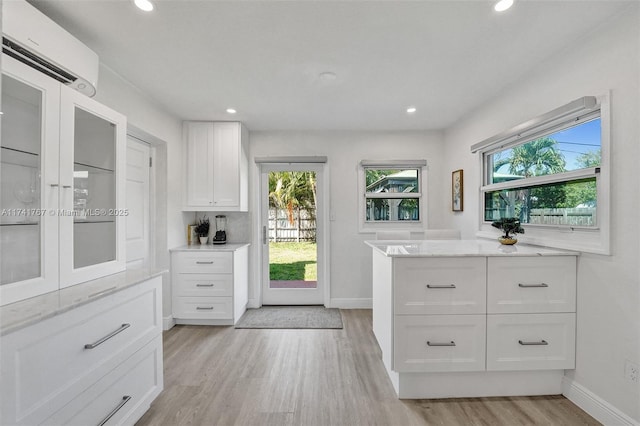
[126,136,150,269]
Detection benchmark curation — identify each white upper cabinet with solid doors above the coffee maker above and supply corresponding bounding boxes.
[183,122,249,211]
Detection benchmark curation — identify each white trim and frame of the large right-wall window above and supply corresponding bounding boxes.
[471,93,611,255]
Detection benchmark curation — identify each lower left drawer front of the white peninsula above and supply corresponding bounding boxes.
[393,315,486,372]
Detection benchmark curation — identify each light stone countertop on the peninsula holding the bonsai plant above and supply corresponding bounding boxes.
[365,240,580,258]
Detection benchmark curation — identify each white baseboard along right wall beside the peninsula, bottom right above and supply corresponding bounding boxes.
[562,376,640,426]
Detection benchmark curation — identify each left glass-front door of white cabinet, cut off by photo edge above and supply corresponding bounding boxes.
[0,55,60,305]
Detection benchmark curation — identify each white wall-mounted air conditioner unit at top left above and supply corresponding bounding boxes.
[1,0,99,96]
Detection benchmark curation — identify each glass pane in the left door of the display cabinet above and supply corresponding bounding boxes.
[0,75,43,285]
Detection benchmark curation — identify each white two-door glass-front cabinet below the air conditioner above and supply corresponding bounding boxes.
[0,54,126,305]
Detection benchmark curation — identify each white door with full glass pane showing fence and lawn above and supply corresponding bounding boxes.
[260,164,325,305]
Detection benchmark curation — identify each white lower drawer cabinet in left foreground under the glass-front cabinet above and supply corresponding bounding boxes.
[0,277,163,425]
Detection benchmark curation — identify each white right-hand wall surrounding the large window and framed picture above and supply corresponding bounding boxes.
[443,4,640,423]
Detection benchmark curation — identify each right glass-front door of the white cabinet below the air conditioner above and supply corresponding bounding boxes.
[60,87,127,287]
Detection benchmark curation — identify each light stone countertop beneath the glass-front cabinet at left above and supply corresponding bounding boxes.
[0,269,167,336]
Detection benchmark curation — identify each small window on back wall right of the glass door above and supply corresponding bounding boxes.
[359,161,426,229]
